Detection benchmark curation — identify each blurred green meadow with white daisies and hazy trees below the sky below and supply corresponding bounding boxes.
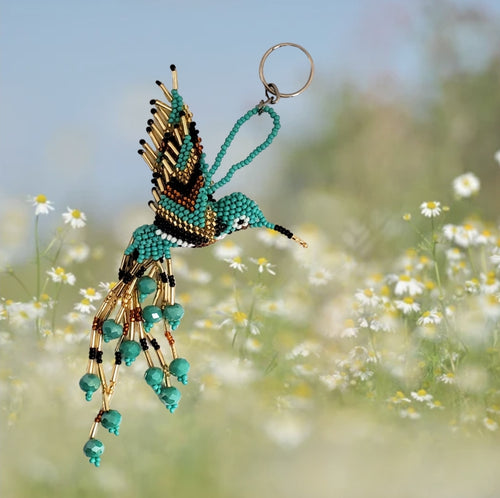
[4,8,500,498]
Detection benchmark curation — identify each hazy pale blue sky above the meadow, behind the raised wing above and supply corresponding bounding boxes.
[0,0,500,216]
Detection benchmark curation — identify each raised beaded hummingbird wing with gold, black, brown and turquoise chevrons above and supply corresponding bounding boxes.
[138,66,217,247]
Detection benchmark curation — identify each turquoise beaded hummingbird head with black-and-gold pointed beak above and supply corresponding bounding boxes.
[213,192,307,247]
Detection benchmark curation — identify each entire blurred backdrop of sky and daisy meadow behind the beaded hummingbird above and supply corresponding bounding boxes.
[0,0,500,498]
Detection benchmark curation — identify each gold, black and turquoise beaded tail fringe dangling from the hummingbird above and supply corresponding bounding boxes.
[80,256,189,466]
